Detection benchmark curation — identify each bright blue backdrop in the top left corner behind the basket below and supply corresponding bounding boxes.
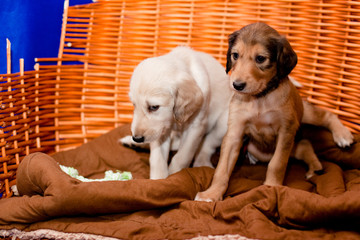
[0,0,91,74]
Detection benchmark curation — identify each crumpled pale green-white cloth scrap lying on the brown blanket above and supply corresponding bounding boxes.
[60,165,132,182]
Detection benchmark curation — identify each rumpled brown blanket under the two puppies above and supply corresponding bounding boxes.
[0,126,360,239]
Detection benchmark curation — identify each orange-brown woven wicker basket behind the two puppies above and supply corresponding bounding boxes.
[0,0,360,197]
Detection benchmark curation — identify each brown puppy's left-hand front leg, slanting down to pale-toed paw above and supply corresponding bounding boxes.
[195,117,245,202]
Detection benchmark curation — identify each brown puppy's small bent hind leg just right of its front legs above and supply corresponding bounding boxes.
[292,139,323,179]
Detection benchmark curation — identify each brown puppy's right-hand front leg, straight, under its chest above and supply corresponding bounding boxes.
[264,124,297,186]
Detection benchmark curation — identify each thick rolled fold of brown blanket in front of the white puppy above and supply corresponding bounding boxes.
[0,153,217,222]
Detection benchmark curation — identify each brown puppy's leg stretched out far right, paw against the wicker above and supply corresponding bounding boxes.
[302,101,354,147]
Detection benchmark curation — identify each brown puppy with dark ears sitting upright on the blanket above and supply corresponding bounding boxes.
[195,23,353,201]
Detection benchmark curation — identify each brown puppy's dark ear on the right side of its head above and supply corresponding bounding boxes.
[277,37,297,79]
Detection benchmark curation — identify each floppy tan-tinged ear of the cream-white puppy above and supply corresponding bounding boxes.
[174,79,204,124]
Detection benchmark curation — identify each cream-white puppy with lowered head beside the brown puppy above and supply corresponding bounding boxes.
[121,46,232,179]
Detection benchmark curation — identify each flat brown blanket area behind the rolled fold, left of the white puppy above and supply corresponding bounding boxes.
[52,125,150,179]
